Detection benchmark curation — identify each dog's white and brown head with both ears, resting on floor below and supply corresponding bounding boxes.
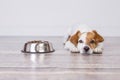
[70,30,104,54]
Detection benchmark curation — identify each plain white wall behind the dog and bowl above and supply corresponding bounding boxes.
[0,0,120,36]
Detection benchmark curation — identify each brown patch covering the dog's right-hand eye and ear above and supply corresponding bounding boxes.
[86,30,104,49]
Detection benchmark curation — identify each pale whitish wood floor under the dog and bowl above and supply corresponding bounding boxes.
[0,37,120,80]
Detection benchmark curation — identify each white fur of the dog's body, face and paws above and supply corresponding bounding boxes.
[64,24,103,54]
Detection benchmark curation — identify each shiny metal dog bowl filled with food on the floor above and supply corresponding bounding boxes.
[22,40,55,53]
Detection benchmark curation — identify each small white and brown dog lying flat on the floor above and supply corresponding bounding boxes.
[64,24,104,54]
